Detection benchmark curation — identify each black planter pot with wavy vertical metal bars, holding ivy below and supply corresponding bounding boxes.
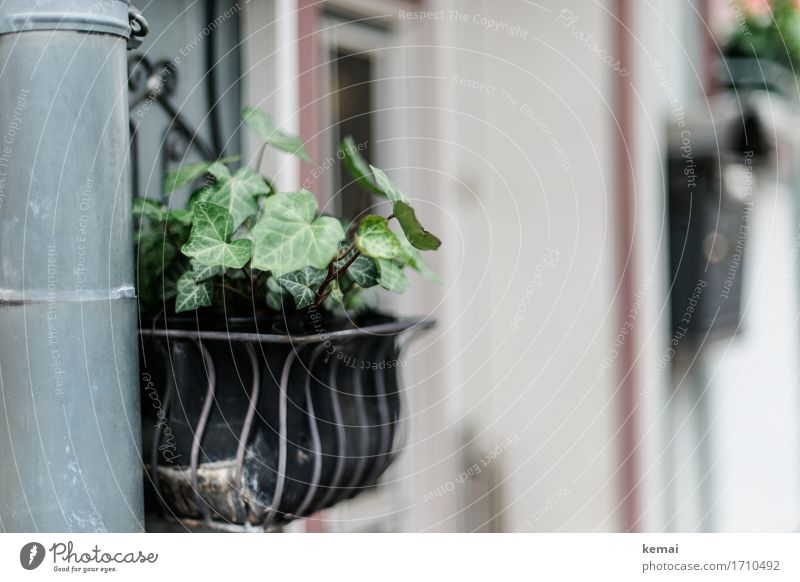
[141,312,429,528]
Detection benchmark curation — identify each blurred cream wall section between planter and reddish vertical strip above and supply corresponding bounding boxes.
[409,0,621,531]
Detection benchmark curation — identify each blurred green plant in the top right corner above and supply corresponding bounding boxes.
[723,0,800,74]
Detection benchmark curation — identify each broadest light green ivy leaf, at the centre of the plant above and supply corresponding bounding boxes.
[252,190,344,277]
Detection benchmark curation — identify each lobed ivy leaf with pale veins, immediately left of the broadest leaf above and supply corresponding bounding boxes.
[181,202,253,269]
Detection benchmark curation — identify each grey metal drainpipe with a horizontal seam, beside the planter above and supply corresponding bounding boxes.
[0,0,147,532]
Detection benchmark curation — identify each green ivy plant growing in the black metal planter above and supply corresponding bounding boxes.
[133,108,441,315]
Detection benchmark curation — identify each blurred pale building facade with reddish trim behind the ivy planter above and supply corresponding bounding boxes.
[134,0,800,532]
